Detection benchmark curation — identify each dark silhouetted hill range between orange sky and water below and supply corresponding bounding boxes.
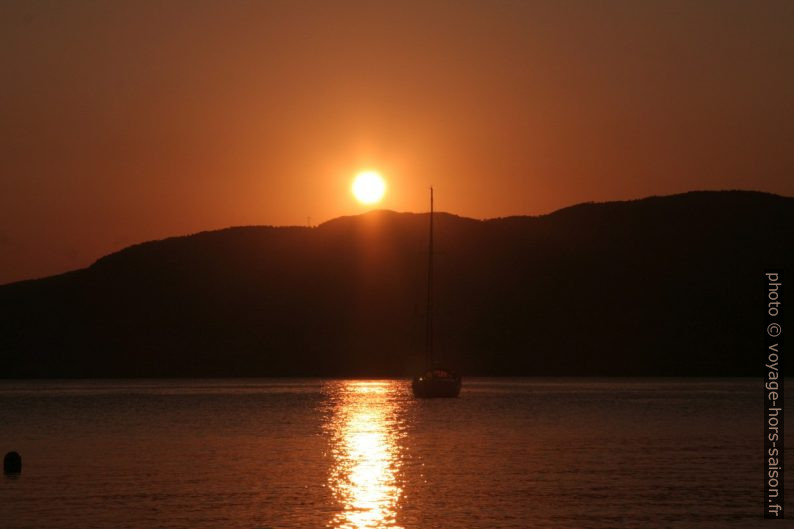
[0,191,794,377]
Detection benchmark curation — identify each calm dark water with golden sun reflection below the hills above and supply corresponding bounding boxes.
[0,379,794,529]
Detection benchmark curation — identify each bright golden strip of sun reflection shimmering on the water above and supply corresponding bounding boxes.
[326,381,403,529]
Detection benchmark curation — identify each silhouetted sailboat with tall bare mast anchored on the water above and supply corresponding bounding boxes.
[411,187,461,398]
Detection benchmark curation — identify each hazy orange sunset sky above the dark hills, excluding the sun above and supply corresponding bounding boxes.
[0,0,794,283]
